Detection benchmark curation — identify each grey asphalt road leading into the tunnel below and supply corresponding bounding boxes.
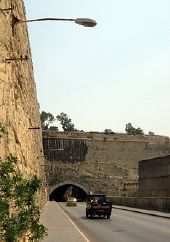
[60,203,170,242]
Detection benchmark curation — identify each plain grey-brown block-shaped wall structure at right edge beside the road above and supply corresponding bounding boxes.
[139,156,170,197]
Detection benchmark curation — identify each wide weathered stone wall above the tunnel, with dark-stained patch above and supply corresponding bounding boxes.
[43,132,170,195]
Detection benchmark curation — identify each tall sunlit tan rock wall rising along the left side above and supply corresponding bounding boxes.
[0,0,45,207]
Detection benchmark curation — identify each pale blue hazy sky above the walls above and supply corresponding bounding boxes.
[24,0,170,137]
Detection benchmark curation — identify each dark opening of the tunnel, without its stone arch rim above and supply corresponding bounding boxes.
[49,184,87,202]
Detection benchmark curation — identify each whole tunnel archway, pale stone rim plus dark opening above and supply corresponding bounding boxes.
[49,181,88,202]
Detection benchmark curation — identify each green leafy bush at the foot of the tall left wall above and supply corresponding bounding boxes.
[0,155,47,242]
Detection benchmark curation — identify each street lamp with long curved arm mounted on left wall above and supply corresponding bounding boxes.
[13,16,97,27]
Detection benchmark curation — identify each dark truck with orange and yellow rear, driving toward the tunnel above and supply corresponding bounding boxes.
[86,194,112,219]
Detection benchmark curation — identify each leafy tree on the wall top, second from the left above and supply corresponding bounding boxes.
[56,112,76,132]
